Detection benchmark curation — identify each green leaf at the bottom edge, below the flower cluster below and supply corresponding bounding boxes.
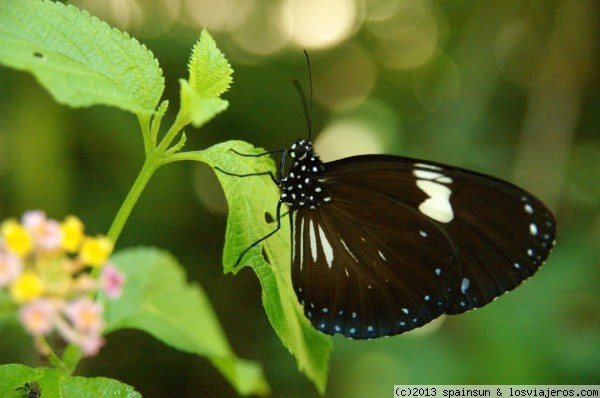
[0,364,141,398]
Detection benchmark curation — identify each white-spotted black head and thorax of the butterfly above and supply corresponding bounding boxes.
[279,140,331,209]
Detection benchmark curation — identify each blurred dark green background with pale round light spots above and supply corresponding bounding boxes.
[0,0,600,397]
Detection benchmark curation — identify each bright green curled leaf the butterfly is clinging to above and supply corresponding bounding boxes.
[186,141,332,393]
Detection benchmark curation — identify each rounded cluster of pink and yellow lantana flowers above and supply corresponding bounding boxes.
[0,210,125,355]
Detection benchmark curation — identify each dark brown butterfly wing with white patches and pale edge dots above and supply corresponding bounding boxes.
[290,155,556,338]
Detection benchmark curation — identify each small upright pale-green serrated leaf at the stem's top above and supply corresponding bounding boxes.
[188,29,233,98]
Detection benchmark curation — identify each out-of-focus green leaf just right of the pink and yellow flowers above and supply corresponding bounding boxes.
[103,247,269,395]
